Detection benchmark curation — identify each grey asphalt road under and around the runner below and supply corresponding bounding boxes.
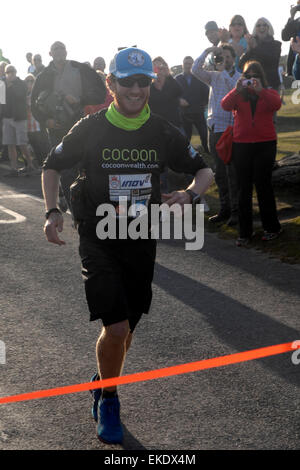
[0,169,300,450]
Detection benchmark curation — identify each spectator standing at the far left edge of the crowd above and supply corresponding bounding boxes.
[2,64,36,176]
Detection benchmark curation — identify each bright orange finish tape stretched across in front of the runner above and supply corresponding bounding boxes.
[0,343,300,404]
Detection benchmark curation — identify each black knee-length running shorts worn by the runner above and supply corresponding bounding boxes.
[78,222,156,332]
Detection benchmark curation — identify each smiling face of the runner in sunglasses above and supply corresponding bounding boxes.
[110,75,150,118]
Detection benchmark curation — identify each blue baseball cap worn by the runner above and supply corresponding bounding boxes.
[109,47,156,78]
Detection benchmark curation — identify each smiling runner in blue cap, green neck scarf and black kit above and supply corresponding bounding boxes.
[42,48,213,444]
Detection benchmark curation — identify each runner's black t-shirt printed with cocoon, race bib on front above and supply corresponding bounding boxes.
[43,110,207,218]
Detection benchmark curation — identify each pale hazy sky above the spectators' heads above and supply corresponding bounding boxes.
[0,0,296,78]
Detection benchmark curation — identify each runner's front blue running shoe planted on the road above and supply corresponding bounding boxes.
[97,395,123,444]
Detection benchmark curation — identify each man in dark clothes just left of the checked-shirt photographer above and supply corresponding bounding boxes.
[175,56,209,152]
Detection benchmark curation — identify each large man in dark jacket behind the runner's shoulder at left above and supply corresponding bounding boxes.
[31,41,106,210]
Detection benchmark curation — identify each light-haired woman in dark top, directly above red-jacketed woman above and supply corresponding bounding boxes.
[239,18,281,91]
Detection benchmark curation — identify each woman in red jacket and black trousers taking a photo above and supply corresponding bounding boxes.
[221,61,281,246]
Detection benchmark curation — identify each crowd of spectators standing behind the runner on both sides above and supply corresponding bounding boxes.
[0,4,300,246]
